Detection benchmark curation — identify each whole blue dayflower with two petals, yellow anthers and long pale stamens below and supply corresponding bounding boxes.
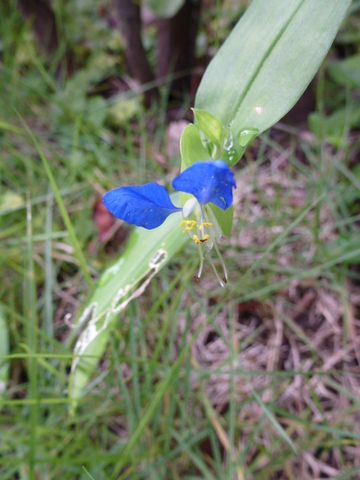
[103,160,236,285]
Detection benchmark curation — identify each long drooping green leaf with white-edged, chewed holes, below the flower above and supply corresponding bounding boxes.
[69,213,188,411]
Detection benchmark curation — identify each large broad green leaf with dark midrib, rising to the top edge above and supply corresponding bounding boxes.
[195,0,351,136]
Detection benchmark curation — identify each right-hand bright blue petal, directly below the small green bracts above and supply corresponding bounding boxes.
[172,161,236,210]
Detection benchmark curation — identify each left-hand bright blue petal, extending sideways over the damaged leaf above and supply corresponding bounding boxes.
[103,183,181,230]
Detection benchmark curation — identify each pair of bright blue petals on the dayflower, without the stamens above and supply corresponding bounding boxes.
[103,161,236,230]
